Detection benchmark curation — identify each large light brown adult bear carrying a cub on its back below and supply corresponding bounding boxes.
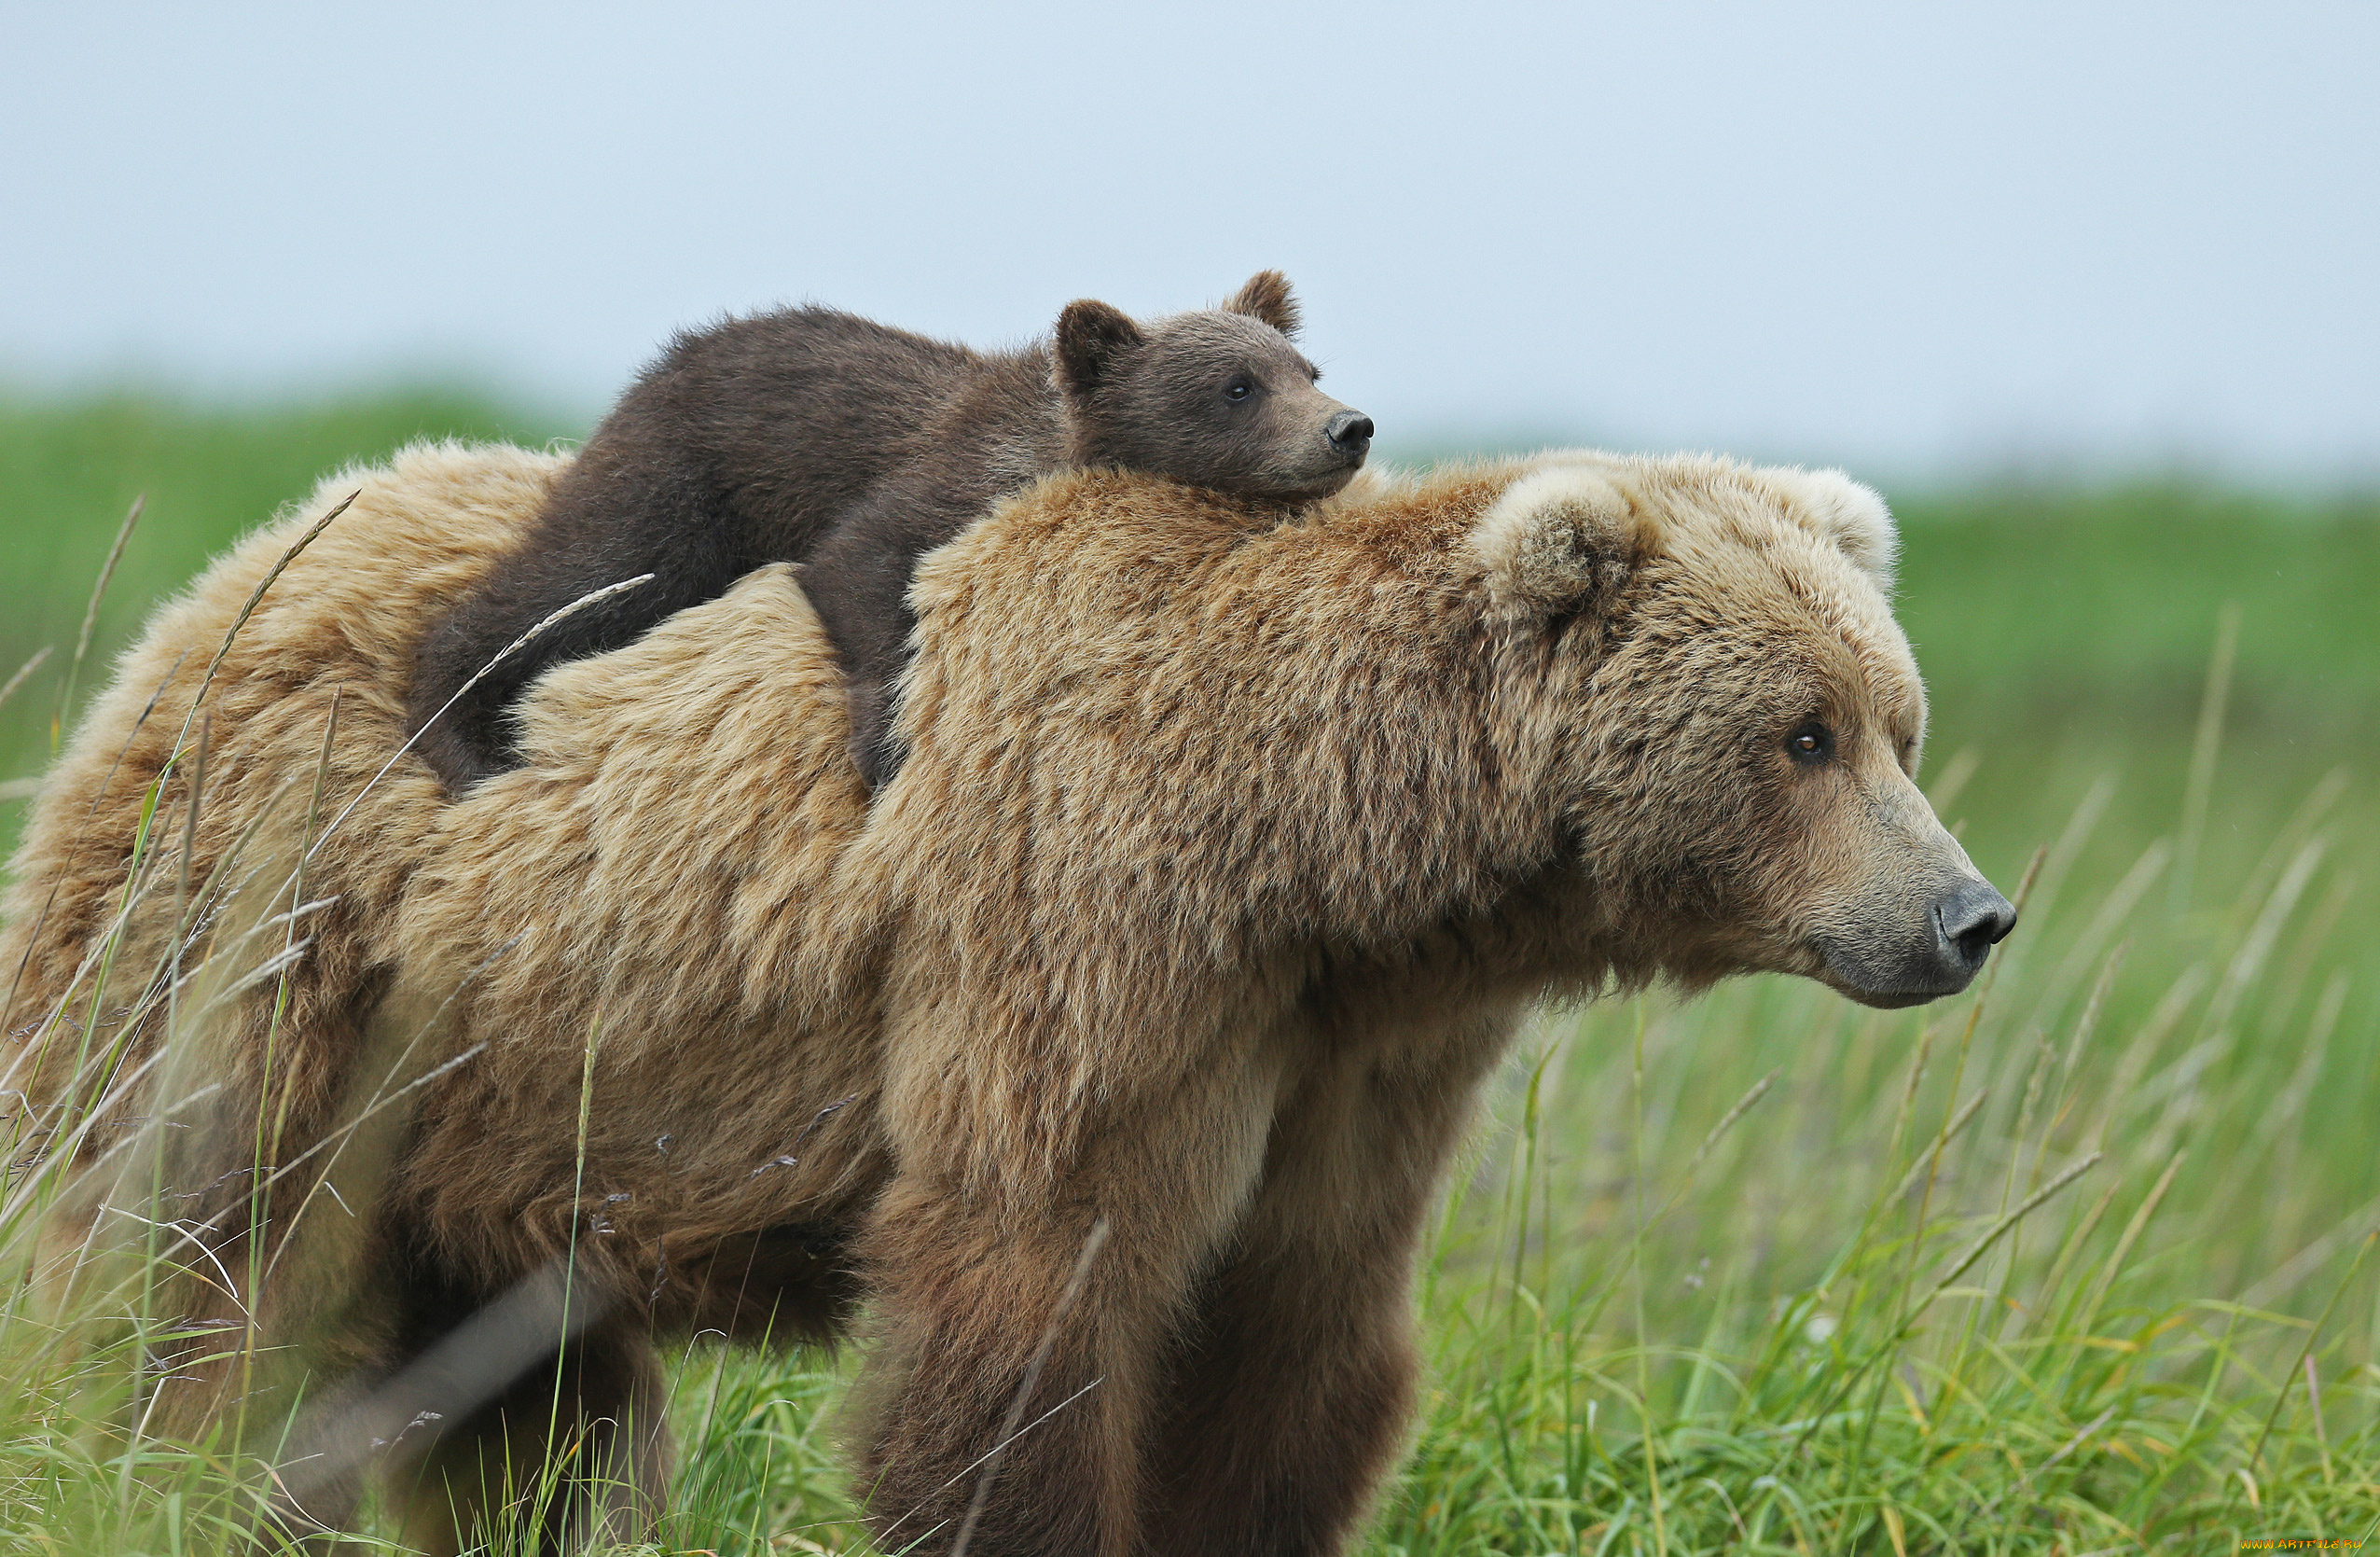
[0,448,2011,1557]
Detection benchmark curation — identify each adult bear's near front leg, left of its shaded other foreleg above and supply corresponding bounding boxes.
[859,1066,1273,1557]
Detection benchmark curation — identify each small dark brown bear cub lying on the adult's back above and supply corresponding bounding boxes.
[407,271,1371,793]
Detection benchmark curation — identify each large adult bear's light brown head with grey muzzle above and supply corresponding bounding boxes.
[1471,454,2016,1007]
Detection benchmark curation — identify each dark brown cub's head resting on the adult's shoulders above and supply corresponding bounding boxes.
[1055,271,1371,502]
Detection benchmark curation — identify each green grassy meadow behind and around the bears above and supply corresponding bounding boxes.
[0,396,2380,1557]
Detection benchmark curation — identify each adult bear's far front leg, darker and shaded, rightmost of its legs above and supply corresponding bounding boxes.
[1145,1017,1509,1557]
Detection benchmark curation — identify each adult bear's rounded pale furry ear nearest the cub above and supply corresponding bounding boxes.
[1471,465,1661,619]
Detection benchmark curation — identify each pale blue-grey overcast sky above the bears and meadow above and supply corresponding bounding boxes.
[0,0,2380,481]
